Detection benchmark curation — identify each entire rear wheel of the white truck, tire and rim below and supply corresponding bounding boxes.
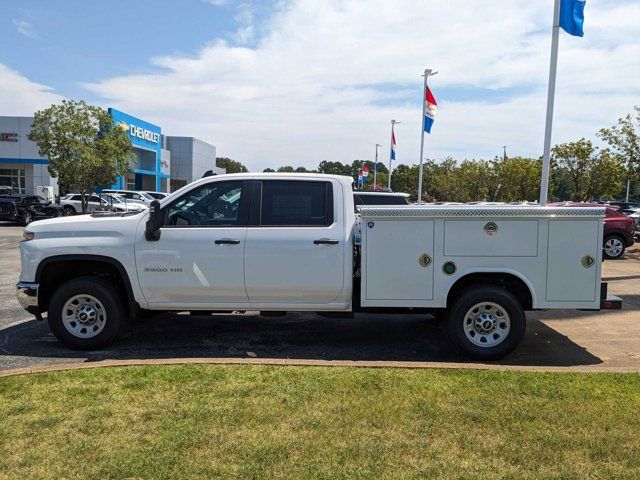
[448,285,526,360]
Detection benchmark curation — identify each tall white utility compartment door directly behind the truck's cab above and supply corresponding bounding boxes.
[362,218,434,300]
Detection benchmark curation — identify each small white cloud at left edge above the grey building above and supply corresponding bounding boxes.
[0,63,62,116]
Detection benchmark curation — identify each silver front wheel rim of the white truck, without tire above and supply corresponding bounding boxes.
[62,294,107,338]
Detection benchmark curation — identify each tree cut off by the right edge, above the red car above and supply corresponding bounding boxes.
[598,105,640,202]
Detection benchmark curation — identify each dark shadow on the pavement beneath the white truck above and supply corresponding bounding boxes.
[0,313,602,368]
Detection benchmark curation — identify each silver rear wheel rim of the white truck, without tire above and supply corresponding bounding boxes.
[463,302,511,348]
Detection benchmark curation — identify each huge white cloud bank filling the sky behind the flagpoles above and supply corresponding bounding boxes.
[86,0,640,170]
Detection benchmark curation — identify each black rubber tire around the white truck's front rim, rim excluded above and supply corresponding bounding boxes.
[48,276,125,350]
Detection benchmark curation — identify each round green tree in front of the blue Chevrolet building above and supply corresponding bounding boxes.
[29,100,135,213]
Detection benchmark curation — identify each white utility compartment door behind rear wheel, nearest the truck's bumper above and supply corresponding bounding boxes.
[546,219,602,302]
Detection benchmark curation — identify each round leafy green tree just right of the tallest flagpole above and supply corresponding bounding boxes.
[551,138,624,202]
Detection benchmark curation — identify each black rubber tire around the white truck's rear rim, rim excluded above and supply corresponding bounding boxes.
[447,284,526,360]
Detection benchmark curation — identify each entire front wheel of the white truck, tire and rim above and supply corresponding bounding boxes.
[48,277,125,350]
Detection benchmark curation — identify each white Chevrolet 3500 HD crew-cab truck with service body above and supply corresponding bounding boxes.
[17,174,620,359]
